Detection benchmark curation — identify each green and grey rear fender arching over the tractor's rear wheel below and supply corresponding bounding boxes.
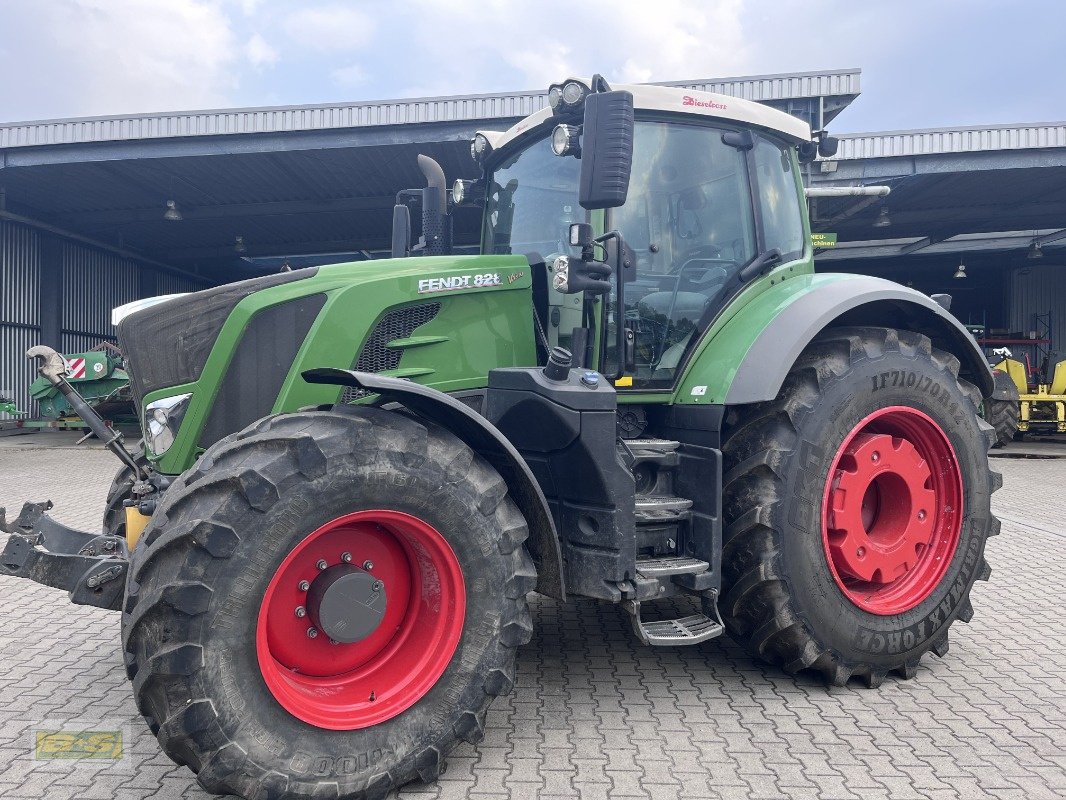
[674,273,994,405]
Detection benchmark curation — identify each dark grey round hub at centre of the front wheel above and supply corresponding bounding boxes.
[307,564,388,644]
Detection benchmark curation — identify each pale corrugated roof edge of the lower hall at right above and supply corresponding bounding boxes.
[834,123,1066,161]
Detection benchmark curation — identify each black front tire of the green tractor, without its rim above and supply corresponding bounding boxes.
[123,407,536,798]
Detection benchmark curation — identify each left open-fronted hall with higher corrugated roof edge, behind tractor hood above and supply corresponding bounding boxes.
[0,69,860,420]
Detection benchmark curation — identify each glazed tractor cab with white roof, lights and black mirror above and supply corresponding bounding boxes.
[405,76,812,390]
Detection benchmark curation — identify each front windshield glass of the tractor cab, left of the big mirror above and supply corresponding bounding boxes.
[485,133,585,256]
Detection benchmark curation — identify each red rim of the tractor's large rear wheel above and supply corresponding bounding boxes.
[822,405,963,615]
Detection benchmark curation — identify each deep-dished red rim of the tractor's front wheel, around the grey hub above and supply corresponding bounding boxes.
[256,510,466,731]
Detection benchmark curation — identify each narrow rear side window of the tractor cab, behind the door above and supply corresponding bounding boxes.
[755,137,804,261]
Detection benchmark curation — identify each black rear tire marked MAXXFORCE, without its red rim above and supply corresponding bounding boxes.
[721,327,1002,687]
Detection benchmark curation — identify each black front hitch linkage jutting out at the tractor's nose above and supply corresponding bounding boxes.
[0,501,129,610]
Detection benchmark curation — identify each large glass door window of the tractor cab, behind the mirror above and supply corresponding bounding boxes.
[604,121,758,389]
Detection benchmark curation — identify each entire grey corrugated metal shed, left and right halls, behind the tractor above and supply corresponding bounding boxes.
[0,69,1066,416]
